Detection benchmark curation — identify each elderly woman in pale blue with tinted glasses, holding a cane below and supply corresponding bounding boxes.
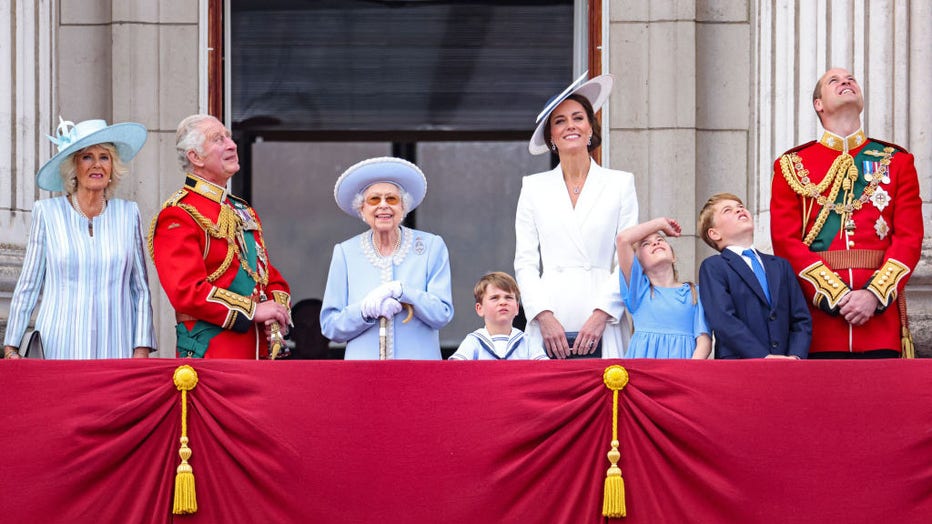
[320,157,453,360]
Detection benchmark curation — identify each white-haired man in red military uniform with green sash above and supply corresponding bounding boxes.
[149,115,291,358]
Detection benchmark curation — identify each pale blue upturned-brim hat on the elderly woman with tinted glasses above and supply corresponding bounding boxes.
[333,156,427,218]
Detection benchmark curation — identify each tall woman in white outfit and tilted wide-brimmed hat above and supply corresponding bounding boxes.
[515,74,638,358]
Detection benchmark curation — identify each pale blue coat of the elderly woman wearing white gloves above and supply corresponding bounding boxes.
[320,227,453,360]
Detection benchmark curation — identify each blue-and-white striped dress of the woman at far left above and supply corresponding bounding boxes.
[4,196,156,359]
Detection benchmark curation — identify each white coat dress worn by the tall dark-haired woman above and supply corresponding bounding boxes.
[515,161,638,358]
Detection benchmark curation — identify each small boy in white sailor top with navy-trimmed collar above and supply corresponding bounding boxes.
[450,271,548,360]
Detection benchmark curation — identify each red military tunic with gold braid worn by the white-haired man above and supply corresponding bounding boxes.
[149,174,291,358]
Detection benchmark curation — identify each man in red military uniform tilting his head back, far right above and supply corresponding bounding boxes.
[770,69,923,358]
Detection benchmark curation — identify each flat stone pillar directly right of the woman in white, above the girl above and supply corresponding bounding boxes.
[603,0,697,278]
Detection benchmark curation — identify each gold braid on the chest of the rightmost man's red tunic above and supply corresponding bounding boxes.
[780,147,895,246]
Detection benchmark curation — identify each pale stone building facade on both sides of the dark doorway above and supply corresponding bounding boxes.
[0,0,932,356]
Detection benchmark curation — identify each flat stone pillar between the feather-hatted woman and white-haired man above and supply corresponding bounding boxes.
[109,0,206,357]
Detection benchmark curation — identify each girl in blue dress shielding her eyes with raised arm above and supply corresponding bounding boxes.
[615,217,712,359]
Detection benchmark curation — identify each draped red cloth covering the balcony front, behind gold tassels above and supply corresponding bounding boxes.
[0,359,932,523]
